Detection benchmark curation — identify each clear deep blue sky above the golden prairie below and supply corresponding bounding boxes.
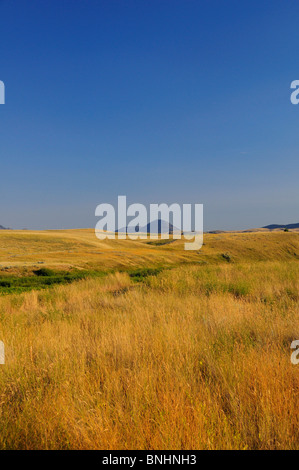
[0,0,299,230]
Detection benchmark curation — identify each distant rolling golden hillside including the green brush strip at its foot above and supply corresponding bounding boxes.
[0,230,299,294]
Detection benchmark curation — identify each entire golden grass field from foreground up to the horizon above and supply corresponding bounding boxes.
[0,230,299,449]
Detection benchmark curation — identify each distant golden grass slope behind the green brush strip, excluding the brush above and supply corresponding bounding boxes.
[0,229,299,273]
